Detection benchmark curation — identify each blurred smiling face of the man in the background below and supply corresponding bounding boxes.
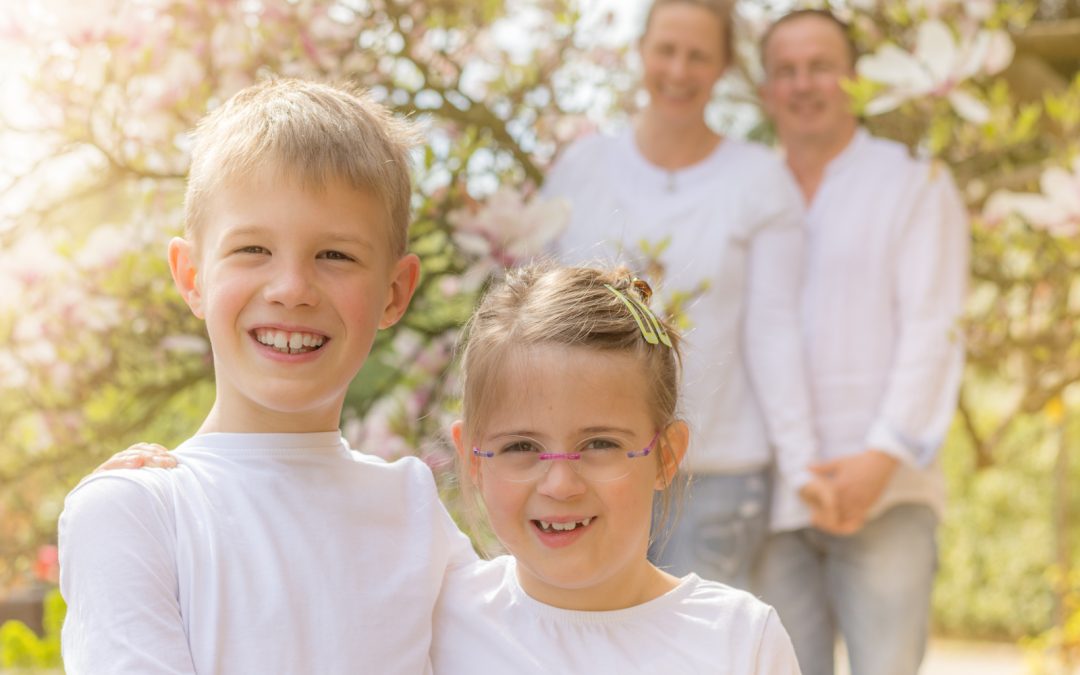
[760,16,855,144]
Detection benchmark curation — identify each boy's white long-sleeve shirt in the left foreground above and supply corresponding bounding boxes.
[59,432,474,675]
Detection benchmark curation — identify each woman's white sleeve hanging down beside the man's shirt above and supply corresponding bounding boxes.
[744,170,819,491]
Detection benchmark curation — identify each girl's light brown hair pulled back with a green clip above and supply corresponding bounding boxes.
[461,262,681,550]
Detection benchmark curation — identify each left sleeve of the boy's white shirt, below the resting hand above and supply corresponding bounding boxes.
[59,474,194,674]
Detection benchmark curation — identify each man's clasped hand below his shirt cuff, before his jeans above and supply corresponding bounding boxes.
[810,449,900,535]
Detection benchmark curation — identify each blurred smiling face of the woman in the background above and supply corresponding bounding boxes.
[638,3,728,125]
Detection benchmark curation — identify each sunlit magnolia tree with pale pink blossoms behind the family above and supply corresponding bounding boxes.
[0,0,1080,652]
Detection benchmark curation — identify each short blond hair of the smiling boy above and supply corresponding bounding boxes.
[184,79,416,256]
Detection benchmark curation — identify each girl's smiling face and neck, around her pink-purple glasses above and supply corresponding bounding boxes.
[454,346,686,609]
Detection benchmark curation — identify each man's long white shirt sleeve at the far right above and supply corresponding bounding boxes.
[866,166,970,467]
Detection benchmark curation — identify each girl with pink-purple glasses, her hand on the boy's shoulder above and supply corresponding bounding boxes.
[95,265,798,675]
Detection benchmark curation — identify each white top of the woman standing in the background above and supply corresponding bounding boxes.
[544,130,818,520]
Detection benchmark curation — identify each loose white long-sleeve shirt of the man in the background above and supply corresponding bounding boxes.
[773,130,969,529]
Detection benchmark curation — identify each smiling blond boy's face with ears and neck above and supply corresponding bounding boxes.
[170,167,419,432]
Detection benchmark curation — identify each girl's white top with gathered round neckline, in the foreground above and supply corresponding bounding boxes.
[431,556,799,675]
